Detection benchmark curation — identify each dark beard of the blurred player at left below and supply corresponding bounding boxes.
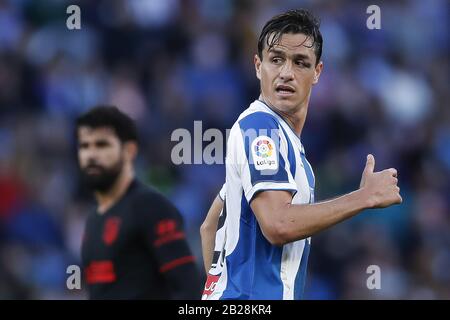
[81,159,123,193]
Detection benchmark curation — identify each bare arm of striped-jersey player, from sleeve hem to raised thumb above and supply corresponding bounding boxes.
[250,155,402,245]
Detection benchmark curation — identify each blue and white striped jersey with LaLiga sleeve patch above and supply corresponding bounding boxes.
[202,100,314,300]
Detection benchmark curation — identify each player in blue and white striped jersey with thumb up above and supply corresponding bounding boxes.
[202,10,402,300]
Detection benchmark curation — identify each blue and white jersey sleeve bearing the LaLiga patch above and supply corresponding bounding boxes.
[229,112,297,203]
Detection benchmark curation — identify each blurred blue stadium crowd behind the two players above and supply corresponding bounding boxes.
[0,0,450,299]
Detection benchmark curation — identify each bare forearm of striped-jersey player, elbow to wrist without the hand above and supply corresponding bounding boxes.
[278,189,370,243]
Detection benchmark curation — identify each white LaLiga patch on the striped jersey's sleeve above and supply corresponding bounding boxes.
[251,136,278,170]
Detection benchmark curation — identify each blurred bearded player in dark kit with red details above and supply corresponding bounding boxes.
[76,106,201,299]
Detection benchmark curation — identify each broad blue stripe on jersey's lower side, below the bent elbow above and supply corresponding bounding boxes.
[220,193,283,300]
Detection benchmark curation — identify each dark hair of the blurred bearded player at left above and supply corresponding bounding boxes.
[76,106,138,142]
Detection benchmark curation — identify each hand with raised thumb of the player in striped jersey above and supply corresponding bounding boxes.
[359,154,402,208]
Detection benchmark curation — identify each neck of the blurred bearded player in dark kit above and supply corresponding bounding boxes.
[95,166,134,214]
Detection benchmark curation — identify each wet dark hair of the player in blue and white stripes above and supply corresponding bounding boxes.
[258,9,323,65]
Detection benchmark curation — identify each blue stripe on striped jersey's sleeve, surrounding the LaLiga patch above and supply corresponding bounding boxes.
[239,111,289,186]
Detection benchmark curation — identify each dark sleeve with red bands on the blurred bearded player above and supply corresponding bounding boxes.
[136,193,202,299]
